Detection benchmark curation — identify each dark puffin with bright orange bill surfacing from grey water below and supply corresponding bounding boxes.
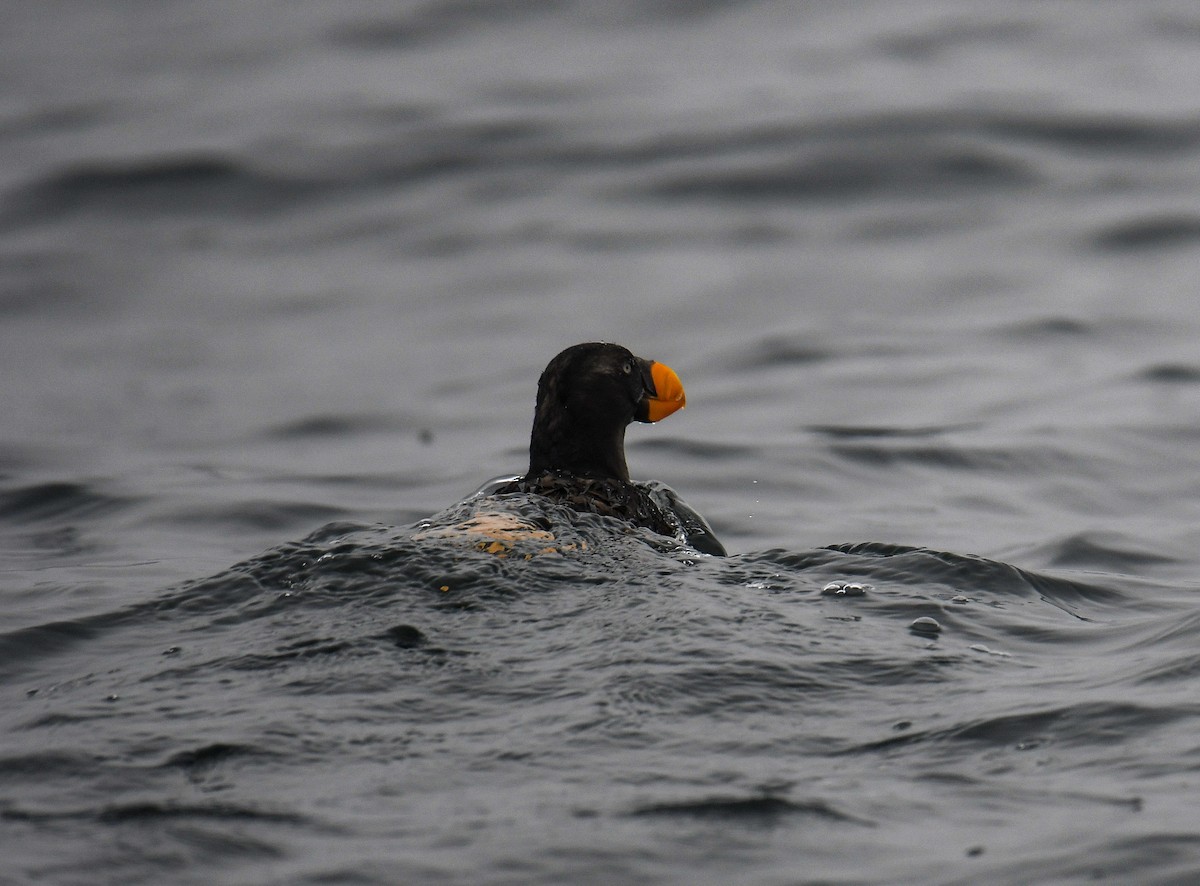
[480,342,725,556]
